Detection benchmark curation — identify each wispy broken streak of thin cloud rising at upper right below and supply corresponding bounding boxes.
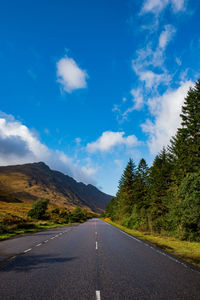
[112,24,176,120]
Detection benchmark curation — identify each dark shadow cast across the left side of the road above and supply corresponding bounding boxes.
[0,254,76,273]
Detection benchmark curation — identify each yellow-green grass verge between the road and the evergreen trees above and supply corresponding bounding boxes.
[102,218,200,267]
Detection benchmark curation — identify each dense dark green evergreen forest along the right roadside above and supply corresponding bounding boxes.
[106,80,200,241]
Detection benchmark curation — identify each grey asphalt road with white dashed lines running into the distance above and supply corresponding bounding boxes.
[0,219,200,300]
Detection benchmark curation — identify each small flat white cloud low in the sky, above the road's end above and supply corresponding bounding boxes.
[86,131,139,153]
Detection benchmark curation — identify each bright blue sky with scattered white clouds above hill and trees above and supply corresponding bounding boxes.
[0,0,200,195]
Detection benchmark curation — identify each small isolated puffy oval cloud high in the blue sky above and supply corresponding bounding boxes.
[57,56,88,93]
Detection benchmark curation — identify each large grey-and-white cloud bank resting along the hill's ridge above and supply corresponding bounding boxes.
[0,113,96,184]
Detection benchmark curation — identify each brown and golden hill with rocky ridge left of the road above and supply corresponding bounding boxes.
[0,162,112,212]
